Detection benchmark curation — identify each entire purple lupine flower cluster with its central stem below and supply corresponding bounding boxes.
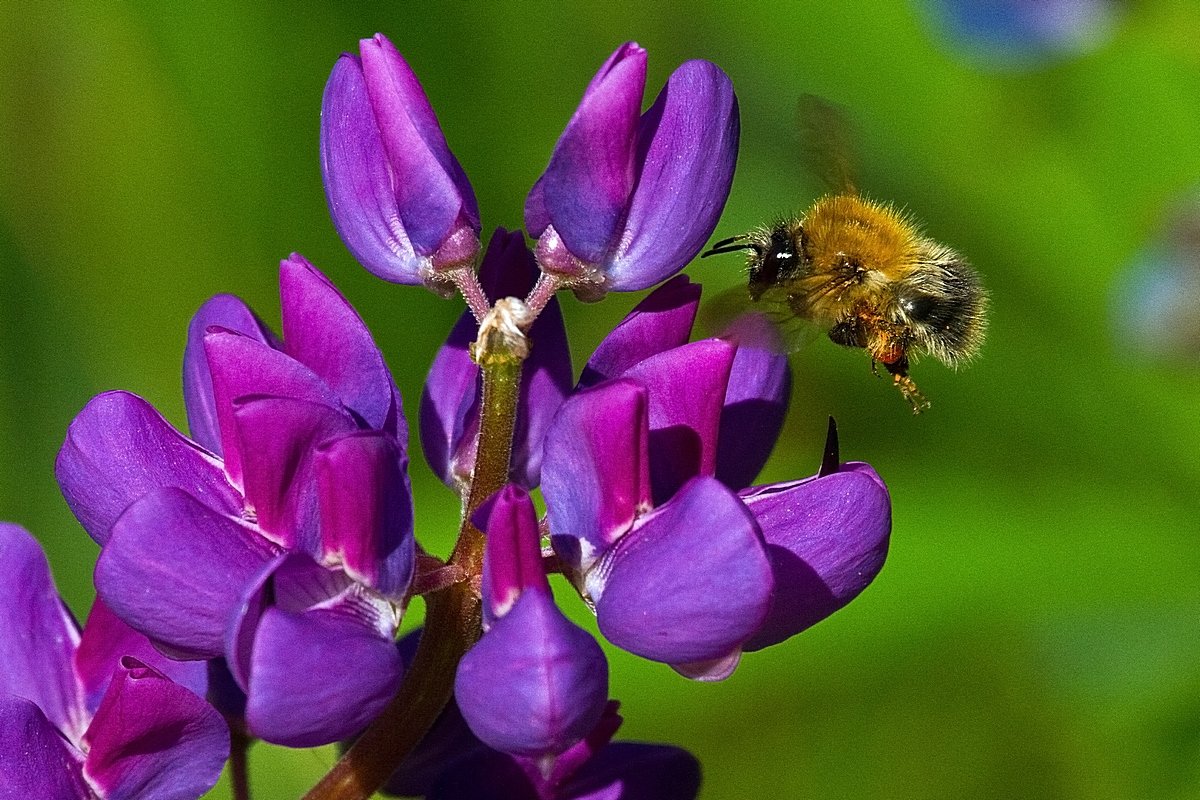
[0,35,890,800]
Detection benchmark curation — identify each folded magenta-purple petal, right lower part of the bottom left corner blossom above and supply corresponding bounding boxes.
[84,657,229,800]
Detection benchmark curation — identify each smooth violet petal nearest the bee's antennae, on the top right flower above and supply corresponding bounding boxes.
[605,61,740,291]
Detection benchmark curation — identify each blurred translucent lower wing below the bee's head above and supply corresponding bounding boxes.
[700,287,821,353]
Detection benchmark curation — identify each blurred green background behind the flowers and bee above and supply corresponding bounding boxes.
[0,0,1200,800]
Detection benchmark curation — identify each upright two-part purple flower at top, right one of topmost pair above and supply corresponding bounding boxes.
[526,42,739,293]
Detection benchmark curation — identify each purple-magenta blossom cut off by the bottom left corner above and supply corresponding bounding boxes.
[0,523,229,800]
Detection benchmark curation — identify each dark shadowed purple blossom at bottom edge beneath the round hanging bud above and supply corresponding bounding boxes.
[427,703,700,800]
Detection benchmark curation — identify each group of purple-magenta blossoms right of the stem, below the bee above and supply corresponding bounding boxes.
[542,278,890,680]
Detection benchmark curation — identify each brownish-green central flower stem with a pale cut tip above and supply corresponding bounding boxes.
[305,301,528,800]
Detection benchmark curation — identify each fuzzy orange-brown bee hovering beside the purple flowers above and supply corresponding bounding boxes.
[703,97,988,414]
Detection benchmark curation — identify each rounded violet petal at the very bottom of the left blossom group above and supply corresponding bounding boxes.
[246,608,403,747]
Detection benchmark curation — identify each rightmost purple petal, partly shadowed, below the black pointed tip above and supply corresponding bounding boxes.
[742,464,892,650]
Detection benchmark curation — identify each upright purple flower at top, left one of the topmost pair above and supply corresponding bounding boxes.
[320,34,480,291]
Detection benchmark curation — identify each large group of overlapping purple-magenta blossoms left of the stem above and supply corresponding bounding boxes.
[56,255,415,746]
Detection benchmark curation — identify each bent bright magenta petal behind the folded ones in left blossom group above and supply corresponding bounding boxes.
[204,329,340,486]
